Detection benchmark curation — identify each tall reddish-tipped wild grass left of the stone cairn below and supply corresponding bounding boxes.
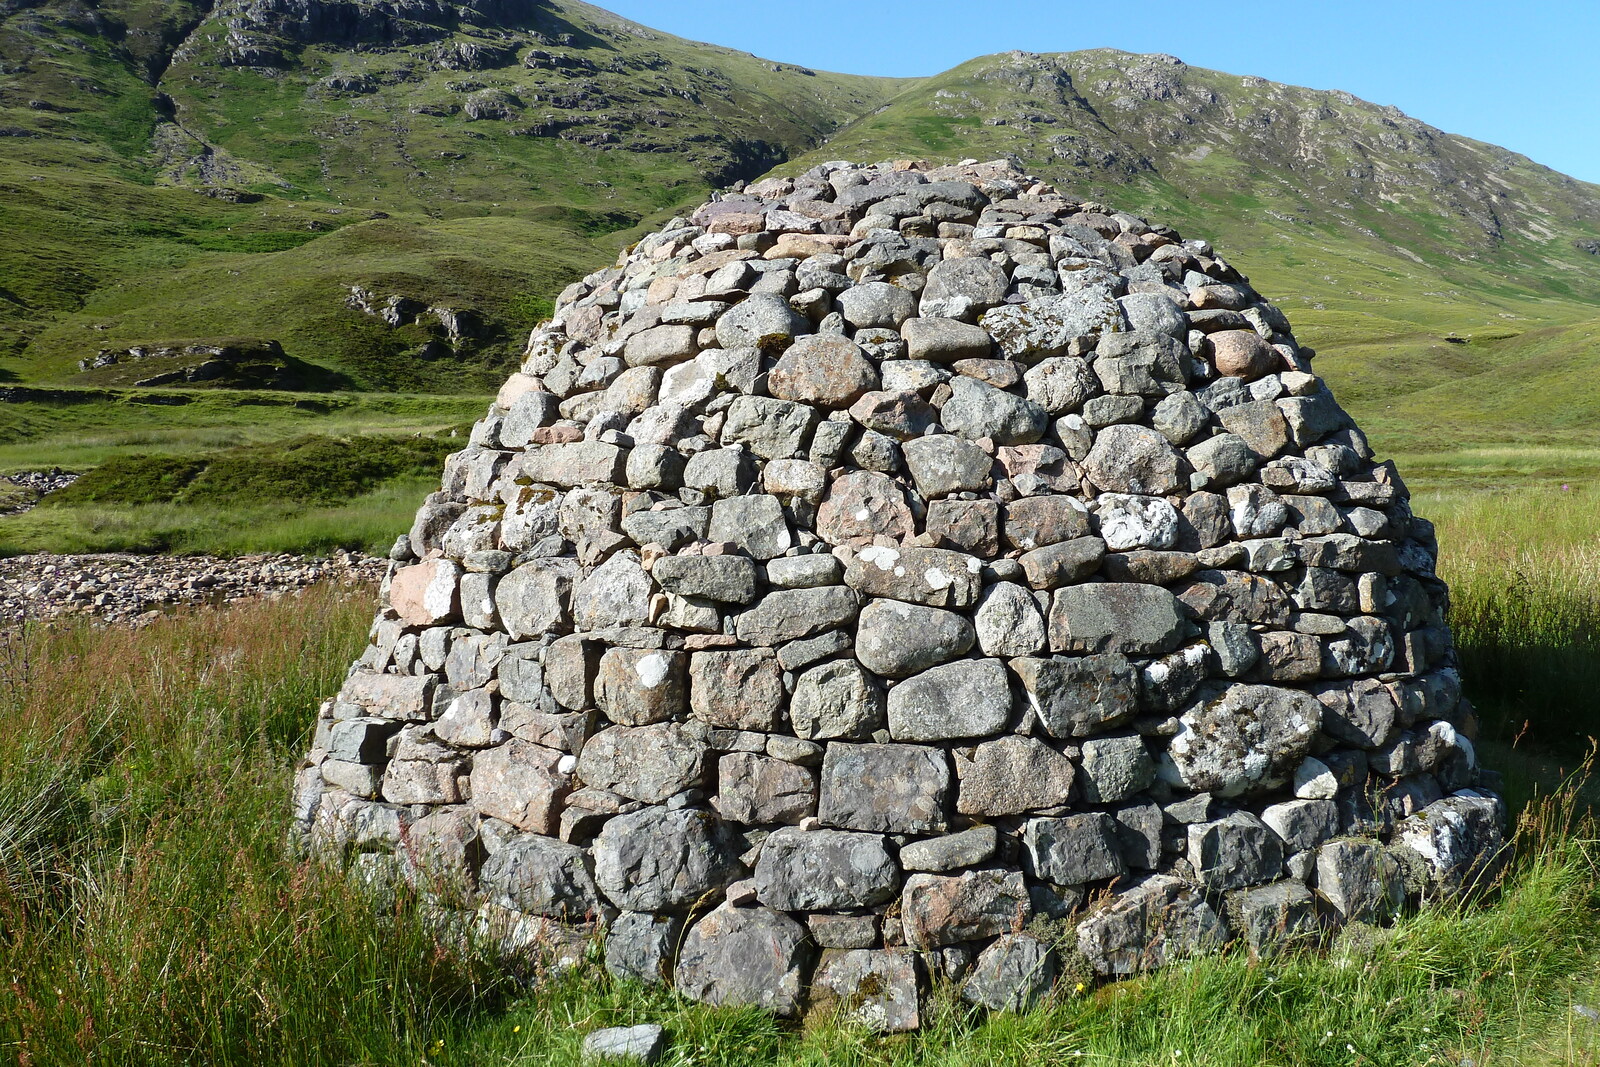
[0,590,508,1065]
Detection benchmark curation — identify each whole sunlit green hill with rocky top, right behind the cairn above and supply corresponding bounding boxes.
[781,50,1600,470]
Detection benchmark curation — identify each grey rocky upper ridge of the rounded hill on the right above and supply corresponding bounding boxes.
[806,50,1600,298]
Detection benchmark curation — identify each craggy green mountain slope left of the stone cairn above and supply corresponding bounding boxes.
[0,0,899,389]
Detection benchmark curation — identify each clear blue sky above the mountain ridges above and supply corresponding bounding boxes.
[600,0,1600,182]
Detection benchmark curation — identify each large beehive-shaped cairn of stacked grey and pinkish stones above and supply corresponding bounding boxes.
[298,162,1504,1030]
